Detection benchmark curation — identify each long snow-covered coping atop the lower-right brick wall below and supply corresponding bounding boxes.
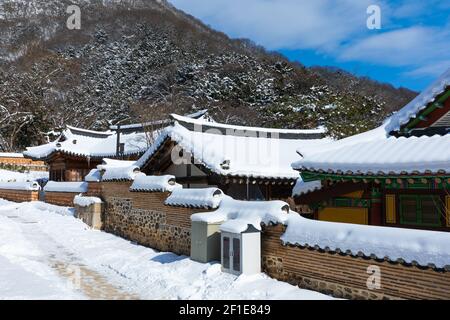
[281,214,450,268]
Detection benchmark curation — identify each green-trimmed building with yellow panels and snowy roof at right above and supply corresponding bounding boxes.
[293,70,450,231]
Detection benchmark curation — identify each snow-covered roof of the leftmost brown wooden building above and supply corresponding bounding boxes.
[23,126,148,159]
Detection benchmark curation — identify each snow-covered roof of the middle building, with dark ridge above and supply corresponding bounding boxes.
[136,117,332,179]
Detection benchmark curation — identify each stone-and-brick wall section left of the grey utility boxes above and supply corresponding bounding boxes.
[102,182,206,256]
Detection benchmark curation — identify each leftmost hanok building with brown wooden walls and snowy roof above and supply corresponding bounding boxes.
[23,126,149,181]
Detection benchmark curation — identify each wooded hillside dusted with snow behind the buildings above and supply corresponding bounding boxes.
[0,0,415,151]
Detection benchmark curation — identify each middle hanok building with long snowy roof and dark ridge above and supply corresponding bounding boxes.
[136,115,329,200]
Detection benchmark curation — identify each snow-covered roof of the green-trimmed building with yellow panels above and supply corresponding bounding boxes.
[292,69,450,175]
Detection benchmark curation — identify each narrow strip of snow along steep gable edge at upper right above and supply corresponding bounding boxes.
[386,69,450,133]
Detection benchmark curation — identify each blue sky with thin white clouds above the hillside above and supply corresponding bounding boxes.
[169,0,450,91]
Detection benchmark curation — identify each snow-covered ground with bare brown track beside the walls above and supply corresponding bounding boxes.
[0,199,331,299]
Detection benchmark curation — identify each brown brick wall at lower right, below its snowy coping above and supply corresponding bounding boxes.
[261,225,450,300]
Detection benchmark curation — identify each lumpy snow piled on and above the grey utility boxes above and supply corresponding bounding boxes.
[191,195,289,233]
